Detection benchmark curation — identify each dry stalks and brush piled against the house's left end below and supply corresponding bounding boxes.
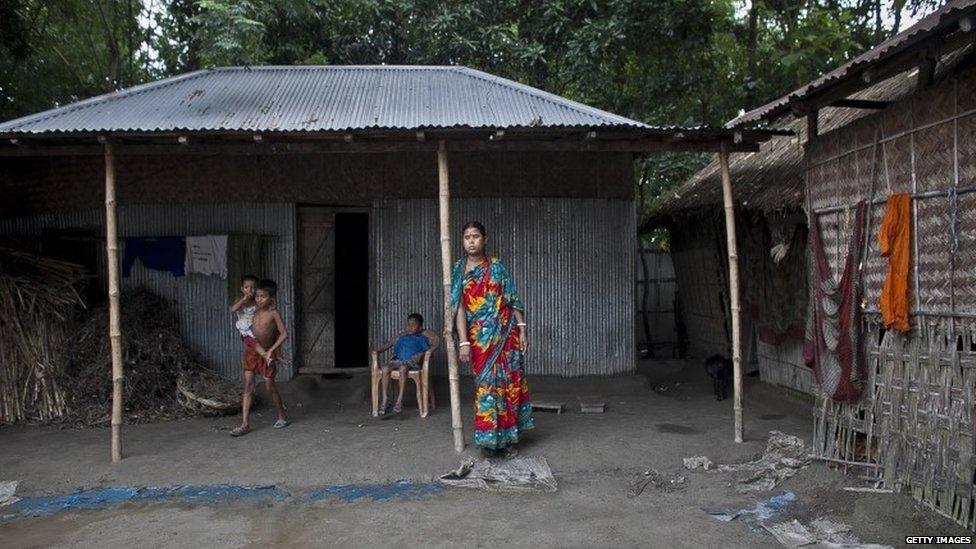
[0,246,242,426]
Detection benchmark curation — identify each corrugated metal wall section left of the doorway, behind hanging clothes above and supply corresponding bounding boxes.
[0,204,295,379]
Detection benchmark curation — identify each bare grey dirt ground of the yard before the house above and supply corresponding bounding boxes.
[0,361,969,547]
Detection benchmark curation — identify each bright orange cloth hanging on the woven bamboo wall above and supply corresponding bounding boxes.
[878,194,912,332]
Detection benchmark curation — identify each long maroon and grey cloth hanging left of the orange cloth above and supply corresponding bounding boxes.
[803,201,866,401]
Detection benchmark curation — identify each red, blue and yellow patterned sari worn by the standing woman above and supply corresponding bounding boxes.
[451,258,533,450]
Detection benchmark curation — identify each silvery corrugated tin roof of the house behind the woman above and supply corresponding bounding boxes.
[0,66,651,135]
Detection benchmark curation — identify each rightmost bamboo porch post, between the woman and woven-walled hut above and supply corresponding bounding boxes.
[718,142,742,442]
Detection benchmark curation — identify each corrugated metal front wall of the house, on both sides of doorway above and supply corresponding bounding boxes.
[0,198,637,379]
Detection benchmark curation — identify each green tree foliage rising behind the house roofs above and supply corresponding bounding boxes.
[0,0,944,233]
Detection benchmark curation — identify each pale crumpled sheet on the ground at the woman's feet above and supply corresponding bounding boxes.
[440,457,557,492]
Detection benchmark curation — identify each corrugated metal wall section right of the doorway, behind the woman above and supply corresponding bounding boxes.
[372,198,636,376]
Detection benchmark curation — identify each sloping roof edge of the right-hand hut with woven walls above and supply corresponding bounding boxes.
[727,0,976,127]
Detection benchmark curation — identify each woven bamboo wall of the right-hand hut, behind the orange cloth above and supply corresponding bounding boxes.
[807,65,976,530]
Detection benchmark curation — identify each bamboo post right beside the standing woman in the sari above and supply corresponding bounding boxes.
[437,141,464,453]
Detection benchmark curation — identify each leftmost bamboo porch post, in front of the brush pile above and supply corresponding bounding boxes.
[105,143,122,463]
